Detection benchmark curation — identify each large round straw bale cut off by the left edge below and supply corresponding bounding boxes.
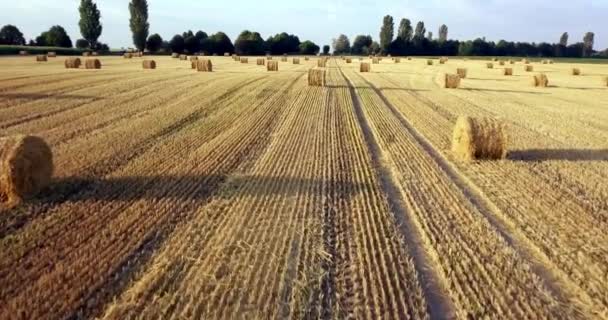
[0,135,54,205]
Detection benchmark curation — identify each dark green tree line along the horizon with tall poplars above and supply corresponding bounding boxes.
[0,0,608,57]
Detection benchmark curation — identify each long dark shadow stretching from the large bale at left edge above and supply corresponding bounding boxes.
[41,175,366,201]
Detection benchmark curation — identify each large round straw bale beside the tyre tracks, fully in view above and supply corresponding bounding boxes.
[452,116,507,161]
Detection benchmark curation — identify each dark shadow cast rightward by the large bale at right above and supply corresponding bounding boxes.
[509,149,608,162]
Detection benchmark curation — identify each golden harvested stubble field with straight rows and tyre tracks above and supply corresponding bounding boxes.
[0,56,608,319]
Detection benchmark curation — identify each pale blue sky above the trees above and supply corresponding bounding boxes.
[0,0,608,50]
